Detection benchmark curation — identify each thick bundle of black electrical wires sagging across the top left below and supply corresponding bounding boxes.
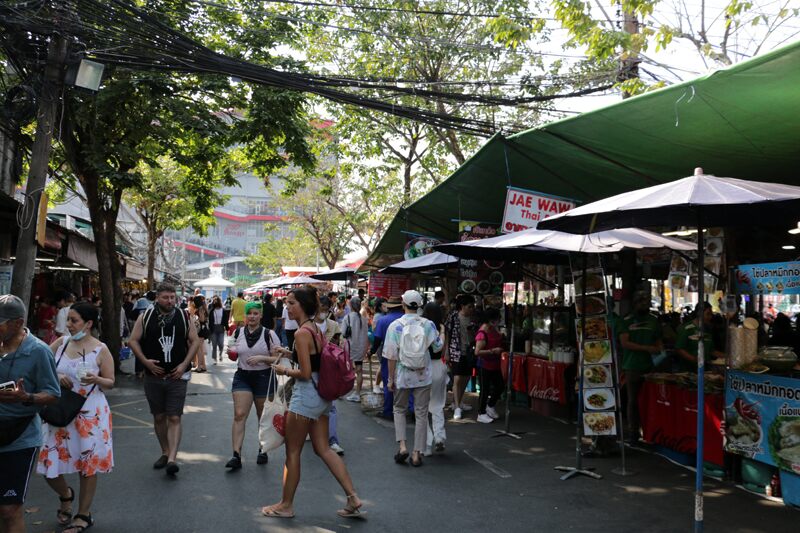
[0,0,612,136]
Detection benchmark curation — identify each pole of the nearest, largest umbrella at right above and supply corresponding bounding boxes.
[694,223,706,533]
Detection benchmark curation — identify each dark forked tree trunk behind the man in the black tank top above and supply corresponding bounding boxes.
[80,175,122,371]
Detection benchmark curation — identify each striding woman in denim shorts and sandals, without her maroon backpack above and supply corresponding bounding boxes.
[261,287,365,518]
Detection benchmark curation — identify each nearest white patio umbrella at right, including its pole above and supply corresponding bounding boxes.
[539,168,800,532]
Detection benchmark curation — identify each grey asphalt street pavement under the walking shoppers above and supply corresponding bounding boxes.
[18,350,800,533]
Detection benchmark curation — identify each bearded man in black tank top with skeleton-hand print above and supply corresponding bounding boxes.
[128,283,203,476]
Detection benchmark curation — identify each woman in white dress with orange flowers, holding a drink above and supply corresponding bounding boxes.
[37,302,114,533]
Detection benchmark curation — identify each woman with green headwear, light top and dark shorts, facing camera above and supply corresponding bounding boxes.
[225,302,280,470]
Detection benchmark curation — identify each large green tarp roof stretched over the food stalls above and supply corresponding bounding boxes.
[365,41,800,268]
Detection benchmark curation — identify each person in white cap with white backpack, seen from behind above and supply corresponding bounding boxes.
[383,290,443,466]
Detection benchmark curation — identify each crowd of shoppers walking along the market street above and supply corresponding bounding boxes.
[0,284,520,533]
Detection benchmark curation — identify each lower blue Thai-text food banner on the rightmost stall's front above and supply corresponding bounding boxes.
[725,371,800,473]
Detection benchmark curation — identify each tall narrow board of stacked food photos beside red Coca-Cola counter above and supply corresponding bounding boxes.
[573,269,619,435]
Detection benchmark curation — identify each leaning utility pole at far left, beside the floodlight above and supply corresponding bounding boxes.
[11,35,67,305]
